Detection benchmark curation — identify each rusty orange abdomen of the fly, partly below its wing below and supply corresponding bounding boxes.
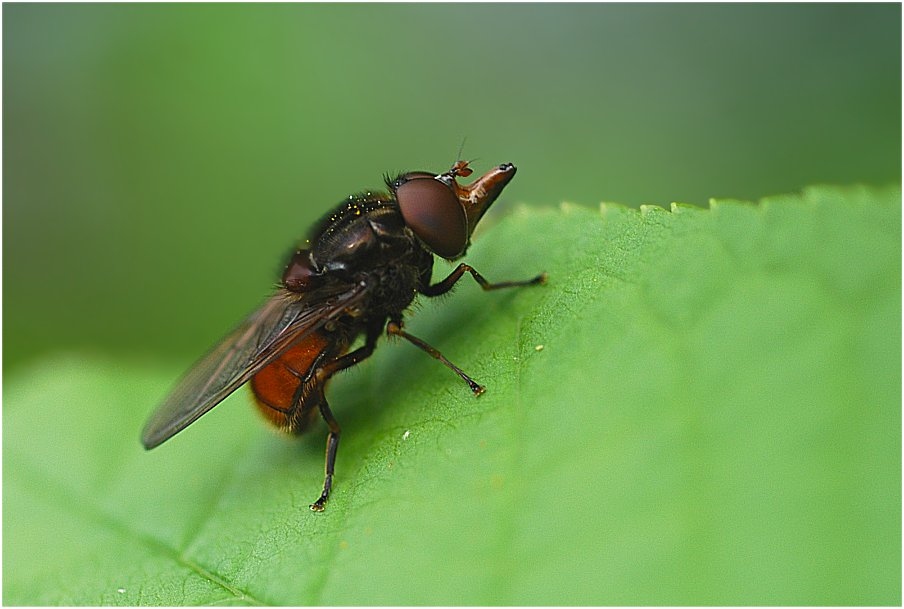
[250,331,347,433]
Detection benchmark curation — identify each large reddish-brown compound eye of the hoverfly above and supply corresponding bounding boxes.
[396,177,469,258]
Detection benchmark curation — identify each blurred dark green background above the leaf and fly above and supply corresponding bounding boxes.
[3,4,901,373]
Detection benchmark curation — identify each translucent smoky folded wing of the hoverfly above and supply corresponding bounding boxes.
[141,282,367,449]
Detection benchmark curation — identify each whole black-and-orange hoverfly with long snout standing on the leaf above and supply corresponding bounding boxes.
[141,161,546,511]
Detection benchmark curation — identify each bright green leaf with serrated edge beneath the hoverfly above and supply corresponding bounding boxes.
[3,187,901,605]
